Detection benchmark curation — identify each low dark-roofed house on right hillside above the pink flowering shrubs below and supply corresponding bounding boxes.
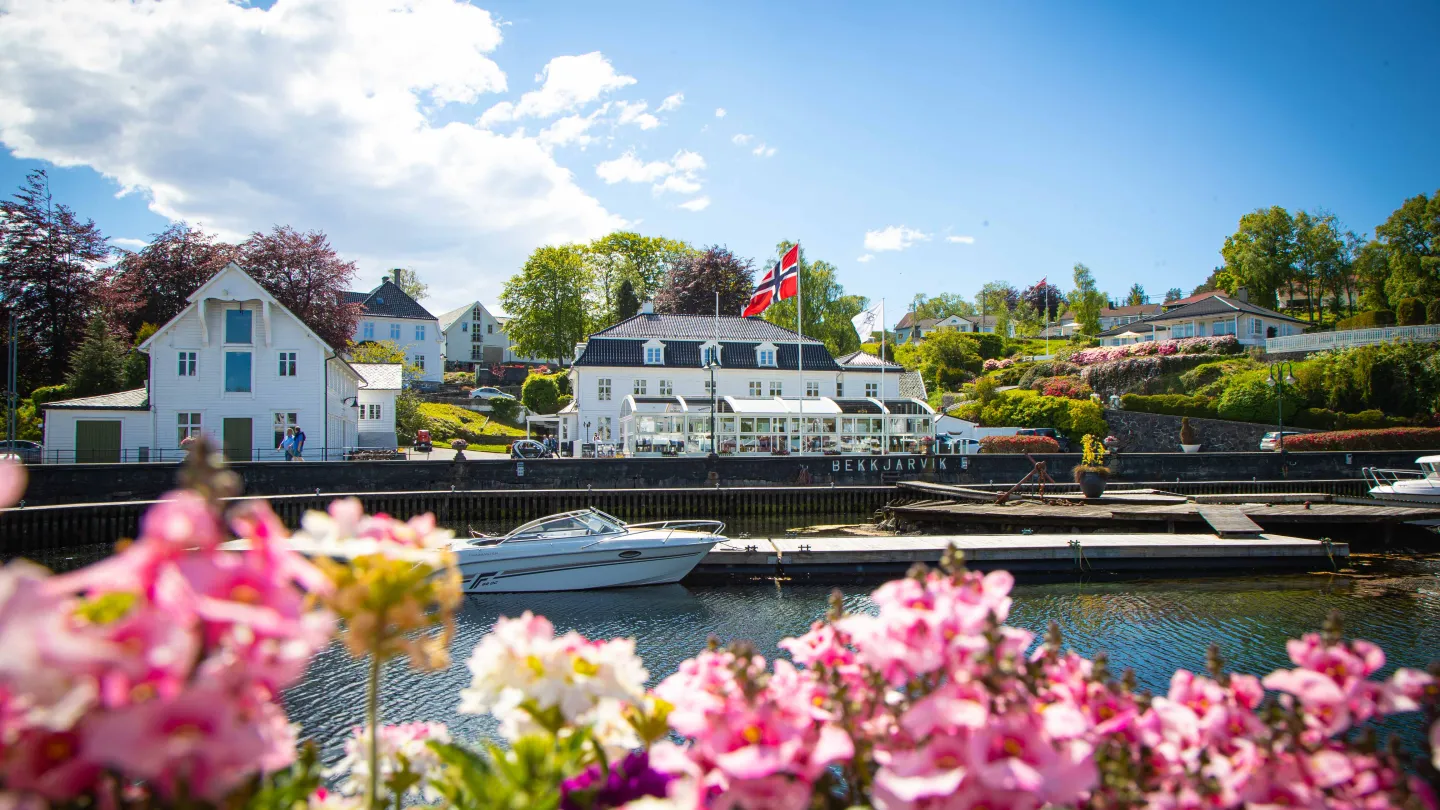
[1099,290,1305,346]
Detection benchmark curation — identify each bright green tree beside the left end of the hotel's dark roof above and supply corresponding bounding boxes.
[500,245,593,365]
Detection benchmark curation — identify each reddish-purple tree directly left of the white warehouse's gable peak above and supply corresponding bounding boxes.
[104,222,238,331]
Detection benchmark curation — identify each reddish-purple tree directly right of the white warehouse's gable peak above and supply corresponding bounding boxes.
[239,225,360,347]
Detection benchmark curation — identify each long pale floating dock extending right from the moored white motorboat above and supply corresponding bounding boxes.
[690,533,1349,581]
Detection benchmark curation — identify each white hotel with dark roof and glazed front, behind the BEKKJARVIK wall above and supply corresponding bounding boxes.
[556,307,935,455]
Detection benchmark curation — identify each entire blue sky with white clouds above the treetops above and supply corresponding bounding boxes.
[0,0,1440,324]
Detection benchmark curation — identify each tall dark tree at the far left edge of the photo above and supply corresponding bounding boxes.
[0,170,109,386]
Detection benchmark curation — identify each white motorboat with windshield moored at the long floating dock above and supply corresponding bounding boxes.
[451,509,724,594]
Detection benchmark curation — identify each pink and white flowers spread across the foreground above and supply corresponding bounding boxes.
[0,449,1440,810]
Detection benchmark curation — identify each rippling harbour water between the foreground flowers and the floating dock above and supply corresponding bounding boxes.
[285,547,1440,758]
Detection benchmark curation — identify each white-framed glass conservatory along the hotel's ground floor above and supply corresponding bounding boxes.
[621,396,936,457]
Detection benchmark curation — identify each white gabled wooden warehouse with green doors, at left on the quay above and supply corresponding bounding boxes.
[45,262,361,463]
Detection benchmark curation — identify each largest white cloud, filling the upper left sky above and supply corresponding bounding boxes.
[0,0,622,300]
